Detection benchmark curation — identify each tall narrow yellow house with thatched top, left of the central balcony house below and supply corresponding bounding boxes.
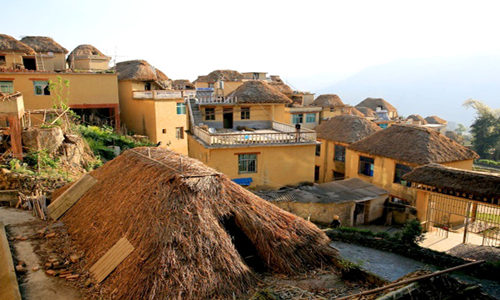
[115,60,195,154]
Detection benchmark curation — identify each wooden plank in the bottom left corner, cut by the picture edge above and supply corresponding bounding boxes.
[0,222,21,300]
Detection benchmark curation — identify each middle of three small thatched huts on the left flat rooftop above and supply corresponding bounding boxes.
[21,36,68,71]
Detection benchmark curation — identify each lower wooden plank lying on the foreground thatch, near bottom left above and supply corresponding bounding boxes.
[90,237,134,283]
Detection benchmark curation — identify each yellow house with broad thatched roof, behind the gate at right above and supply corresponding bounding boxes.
[345,124,478,206]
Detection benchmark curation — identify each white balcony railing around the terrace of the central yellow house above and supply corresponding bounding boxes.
[193,122,316,146]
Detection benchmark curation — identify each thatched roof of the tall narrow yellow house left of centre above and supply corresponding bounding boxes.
[114,60,169,81]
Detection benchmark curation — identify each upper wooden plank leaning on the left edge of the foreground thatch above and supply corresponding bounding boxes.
[47,174,97,220]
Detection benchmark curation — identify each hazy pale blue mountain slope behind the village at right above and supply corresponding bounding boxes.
[316,56,500,126]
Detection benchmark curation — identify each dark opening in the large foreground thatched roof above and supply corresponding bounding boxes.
[221,216,267,272]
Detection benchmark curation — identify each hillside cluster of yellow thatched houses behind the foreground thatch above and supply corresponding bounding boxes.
[0,35,496,232]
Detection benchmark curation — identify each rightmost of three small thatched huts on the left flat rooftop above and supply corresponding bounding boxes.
[67,45,111,71]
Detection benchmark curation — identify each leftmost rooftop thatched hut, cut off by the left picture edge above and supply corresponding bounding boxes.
[0,34,36,70]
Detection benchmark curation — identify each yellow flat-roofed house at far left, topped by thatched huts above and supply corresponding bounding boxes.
[0,34,120,128]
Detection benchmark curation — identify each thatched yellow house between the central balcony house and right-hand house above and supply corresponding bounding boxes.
[314,115,381,183]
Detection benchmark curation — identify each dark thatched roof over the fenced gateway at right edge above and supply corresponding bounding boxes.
[403,164,500,198]
